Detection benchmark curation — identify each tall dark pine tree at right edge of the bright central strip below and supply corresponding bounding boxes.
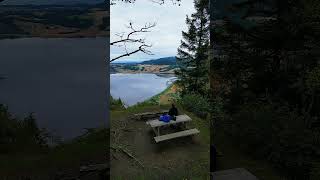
[176,0,209,94]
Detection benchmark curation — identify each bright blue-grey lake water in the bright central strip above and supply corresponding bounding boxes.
[110,73,175,106]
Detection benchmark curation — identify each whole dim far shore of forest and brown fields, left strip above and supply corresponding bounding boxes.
[0,4,109,39]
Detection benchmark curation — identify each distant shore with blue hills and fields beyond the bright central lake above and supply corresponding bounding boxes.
[110,57,178,74]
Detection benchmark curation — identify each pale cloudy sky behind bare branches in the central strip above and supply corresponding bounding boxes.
[110,0,195,62]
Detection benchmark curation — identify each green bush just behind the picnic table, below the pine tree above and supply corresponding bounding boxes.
[178,94,210,118]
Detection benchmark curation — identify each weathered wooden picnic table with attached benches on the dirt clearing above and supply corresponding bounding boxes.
[146,114,200,143]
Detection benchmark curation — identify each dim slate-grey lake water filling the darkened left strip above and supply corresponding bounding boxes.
[0,38,109,139]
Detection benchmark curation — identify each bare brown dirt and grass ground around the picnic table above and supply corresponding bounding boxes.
[110,109,210,179]
